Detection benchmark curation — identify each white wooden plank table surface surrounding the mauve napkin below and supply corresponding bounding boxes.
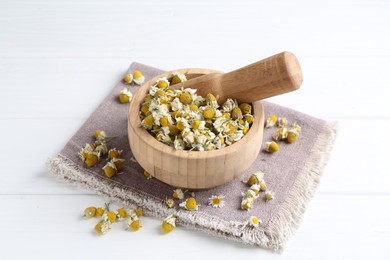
[0,0,390,260]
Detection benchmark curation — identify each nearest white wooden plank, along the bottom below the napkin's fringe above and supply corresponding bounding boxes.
[0,195,390,260]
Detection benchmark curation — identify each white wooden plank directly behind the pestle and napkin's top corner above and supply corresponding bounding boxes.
[0,57,390,120]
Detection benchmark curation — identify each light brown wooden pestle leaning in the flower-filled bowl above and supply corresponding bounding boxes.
[172,51,302,104]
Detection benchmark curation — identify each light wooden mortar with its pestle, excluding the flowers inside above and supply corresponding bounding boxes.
[128,52,302,189]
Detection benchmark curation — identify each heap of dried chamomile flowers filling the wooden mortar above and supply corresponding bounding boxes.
[140,74,253,151]
